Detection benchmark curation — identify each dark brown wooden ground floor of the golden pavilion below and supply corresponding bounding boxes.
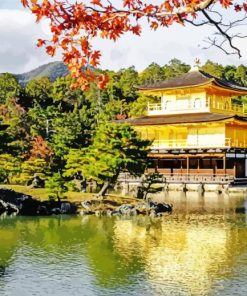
[147,149,247,182]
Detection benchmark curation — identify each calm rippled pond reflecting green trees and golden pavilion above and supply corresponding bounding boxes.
[0,193,247,296]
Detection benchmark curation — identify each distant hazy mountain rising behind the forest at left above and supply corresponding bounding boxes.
[15,62,69,84]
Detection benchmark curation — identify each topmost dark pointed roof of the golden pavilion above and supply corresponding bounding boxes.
[139,71,247,93]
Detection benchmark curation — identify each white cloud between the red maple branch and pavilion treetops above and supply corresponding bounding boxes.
[91,20,247,71]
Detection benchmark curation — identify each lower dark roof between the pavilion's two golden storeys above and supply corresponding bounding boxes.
[121,113,247,126]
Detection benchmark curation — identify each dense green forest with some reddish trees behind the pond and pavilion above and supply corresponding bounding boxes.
[0,59,247,195]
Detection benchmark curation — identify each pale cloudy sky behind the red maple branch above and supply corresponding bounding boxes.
[0,0,247,73]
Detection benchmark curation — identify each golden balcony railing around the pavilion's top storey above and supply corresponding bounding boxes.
[148,97,247,116]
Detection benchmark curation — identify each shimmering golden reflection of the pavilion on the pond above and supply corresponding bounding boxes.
[115,216,247,295]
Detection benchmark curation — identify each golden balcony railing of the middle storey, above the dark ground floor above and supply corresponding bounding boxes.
[151,138,234,149]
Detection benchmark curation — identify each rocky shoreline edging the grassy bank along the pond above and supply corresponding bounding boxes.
[0,186,172,217]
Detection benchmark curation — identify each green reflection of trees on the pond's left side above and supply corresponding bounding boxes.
[0,217,143,288]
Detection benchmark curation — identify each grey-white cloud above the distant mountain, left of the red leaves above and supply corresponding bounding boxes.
[0,9,55,73]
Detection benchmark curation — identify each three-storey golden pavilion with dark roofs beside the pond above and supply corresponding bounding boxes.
[127,71,247,182]
